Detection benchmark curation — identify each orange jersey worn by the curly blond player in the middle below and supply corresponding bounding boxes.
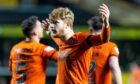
[53,25,110,84]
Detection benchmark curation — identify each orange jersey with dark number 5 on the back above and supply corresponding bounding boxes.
[9,41,58,84]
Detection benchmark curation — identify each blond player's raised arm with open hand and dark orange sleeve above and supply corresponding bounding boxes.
[87,4,110,46]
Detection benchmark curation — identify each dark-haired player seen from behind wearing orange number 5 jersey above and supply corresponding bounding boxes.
[9,16,58,84]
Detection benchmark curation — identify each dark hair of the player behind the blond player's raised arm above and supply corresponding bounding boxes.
[88,16,103,31]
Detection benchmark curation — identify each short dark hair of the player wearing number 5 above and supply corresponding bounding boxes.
[22,16,38,37]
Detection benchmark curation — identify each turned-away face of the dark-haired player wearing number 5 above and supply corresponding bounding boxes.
[35,21,43,38]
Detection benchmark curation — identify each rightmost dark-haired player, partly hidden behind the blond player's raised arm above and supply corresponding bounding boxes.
[88,16,122,84]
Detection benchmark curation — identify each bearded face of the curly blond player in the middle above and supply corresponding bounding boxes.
[51,20,66,37]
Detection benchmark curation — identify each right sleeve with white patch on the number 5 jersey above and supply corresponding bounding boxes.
[43,46,58,61]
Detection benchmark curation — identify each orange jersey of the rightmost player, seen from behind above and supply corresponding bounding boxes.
[89,42,119,84]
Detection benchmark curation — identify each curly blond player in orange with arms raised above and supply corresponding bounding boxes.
[43,4,110,84]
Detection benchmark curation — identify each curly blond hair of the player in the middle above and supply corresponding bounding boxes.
[49,7,74,27]
